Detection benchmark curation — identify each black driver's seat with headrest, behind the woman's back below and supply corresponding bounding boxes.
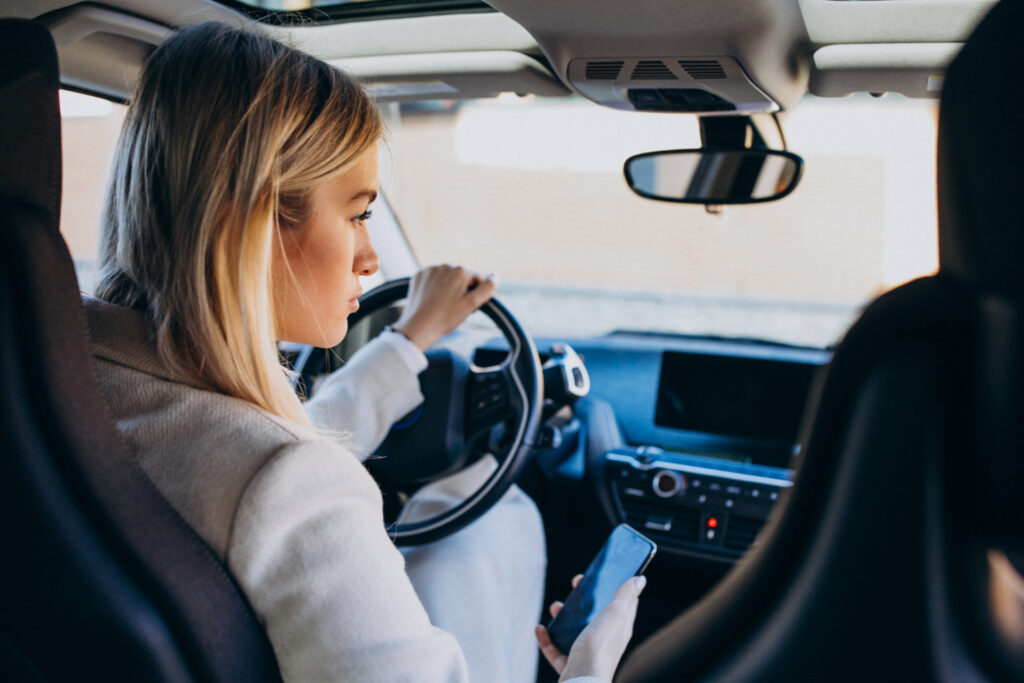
[0,20,281,681]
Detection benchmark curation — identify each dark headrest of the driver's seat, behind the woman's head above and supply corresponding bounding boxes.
[0,19,60,225]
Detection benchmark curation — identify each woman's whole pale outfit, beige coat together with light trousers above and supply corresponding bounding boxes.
[85,298,597,683]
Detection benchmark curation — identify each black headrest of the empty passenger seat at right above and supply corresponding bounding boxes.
[938,0,1024,298]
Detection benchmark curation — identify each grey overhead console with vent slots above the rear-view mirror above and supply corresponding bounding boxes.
[487,0,809,116]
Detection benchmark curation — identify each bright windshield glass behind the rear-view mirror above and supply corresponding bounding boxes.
[381,95,937,347]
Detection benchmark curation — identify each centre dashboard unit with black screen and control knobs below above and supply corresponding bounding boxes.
[599,350,825,562]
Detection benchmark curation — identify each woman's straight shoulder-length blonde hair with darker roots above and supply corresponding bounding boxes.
[96,23,382,427]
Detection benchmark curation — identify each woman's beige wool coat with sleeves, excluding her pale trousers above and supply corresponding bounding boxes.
[85,299,468,682]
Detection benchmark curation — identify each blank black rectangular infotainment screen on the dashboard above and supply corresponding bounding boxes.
[654,351,819,443]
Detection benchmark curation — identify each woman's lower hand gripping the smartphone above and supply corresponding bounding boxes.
[537,574,647,681]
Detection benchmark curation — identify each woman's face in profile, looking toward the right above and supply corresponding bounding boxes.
[271,144,380,347]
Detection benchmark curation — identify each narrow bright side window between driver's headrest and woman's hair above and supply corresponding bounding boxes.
[60,90,126,292]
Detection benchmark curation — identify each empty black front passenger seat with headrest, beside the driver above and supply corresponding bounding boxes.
[616,0,1024,681]
